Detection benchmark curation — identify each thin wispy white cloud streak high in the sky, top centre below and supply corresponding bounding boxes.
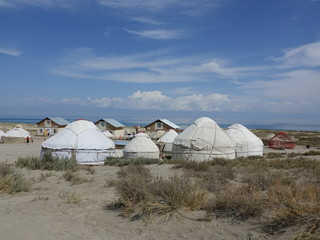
[125,29,187,40]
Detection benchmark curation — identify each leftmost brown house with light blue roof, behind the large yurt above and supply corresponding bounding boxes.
[37,117,69,136]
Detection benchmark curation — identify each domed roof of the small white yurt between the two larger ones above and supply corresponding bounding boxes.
[123,133,159,152]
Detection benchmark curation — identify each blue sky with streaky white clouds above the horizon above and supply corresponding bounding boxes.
[0,0,320,126]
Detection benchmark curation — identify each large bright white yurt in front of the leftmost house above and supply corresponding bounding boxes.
[41,120,115,165]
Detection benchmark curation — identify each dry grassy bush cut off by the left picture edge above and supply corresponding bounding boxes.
[0,163,31,194]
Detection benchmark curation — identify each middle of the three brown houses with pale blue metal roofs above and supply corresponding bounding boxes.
[94,118,126,139]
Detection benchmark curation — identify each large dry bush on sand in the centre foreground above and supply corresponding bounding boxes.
[109,165,208,218]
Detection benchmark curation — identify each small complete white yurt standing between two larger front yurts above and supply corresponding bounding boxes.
[123,133,159,158]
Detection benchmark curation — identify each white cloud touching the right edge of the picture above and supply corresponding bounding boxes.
[274,42,320,68]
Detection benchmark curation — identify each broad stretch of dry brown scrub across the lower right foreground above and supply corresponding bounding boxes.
[112,152,320,240]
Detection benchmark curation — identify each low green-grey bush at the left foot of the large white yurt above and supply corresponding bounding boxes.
[15,153,77,171]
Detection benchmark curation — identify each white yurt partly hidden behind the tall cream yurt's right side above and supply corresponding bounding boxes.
[226,124,263,157]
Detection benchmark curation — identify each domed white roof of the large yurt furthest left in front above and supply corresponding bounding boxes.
[42,120,115,150]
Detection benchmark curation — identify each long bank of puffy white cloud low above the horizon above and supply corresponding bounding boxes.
[63,91,312,112]
